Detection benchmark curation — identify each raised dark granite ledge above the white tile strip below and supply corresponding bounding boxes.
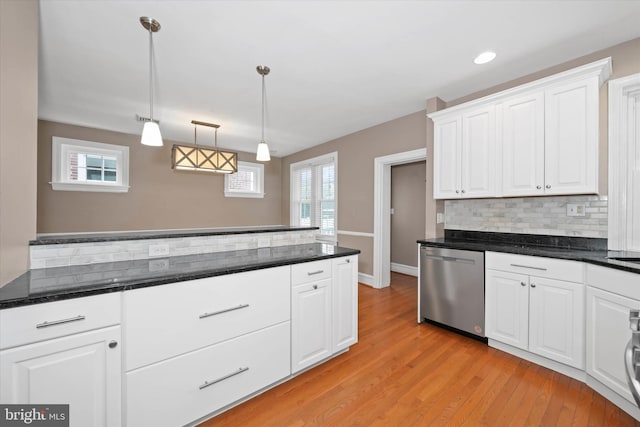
[29,225,318,246]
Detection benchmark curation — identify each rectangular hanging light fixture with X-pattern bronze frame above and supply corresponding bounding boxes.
[171,120,238,173]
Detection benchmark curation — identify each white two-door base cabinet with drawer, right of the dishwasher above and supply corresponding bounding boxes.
[485,252,585,369]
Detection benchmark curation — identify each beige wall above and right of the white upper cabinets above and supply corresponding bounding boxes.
[447,37,640,195]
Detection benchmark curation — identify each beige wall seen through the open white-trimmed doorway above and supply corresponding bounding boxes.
[391,161,427,267]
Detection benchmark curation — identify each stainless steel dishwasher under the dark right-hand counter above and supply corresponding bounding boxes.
[418,246,484,338]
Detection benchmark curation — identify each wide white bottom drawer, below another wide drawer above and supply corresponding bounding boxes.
[126,322,290,427]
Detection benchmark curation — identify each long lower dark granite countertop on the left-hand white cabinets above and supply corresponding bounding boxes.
[0,243,360,309]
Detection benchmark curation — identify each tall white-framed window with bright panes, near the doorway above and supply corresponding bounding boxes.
[291,153,338,243]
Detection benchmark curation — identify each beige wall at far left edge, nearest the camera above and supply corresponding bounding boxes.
[0,0,39,286]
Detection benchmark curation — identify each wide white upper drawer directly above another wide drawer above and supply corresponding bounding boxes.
[124,267,291,370]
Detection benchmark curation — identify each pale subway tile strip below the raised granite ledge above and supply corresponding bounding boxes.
[30,230,318,269]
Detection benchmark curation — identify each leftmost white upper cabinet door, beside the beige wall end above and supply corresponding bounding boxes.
[433,115,462,199]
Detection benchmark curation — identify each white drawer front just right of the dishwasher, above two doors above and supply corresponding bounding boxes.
[484,252,584,283]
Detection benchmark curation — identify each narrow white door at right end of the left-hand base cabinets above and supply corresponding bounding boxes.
[331,256,358,352]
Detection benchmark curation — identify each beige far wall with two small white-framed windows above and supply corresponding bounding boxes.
[38,121,282,233]
